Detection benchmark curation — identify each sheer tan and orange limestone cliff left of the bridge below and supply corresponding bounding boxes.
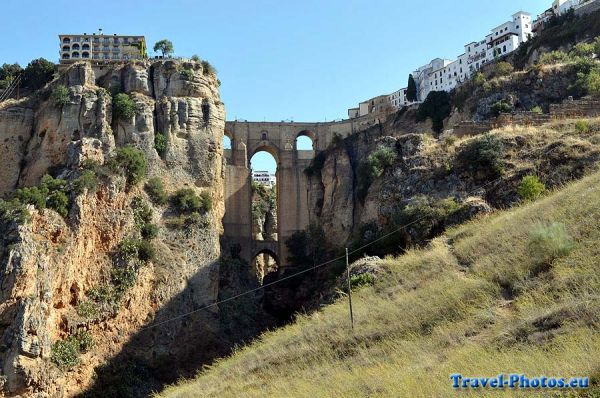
[0,62,225,397]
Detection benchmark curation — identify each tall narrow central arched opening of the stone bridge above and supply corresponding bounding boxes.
[250,148,278,242]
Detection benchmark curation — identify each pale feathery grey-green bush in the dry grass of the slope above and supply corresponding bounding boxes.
[528,222,575,266]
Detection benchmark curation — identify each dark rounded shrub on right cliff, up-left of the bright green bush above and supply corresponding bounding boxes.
[457,134,504,177]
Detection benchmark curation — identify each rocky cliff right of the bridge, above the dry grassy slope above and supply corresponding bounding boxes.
[309,113,600,255]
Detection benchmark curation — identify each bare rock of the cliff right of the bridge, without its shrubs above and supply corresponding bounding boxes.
[309,112,600,252]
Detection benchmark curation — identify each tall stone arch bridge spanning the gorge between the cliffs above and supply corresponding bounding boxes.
[223,116,378,268]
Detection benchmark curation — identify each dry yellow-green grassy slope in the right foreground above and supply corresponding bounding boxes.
[162,148,600,397]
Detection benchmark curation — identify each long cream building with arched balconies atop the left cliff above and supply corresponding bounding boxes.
[58,31,146,64]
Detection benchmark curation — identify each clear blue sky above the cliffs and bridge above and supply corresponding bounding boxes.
[0,0,551,173]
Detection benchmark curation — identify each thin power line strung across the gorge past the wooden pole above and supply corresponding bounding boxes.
[139,138,559,331]
